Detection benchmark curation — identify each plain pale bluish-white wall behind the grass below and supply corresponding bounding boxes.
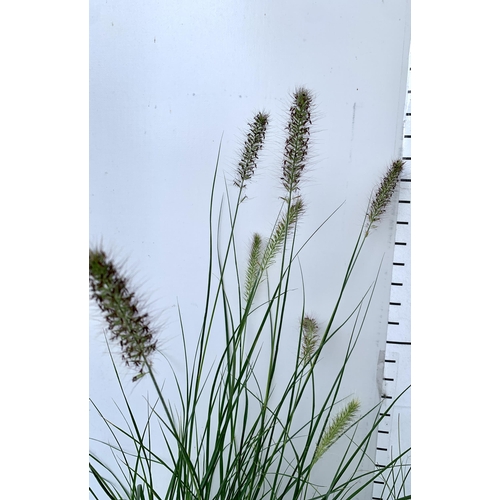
[90,0,410,496]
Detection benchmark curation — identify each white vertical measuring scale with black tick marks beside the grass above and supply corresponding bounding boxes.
[372,52,411,500]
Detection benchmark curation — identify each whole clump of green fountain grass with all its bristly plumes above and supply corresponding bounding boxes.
[89,88,408,500]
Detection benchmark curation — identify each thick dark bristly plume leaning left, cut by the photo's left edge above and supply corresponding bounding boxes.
[89,249,157,381]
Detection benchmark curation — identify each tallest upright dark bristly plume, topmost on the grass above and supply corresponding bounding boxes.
[281,87,313,193]
